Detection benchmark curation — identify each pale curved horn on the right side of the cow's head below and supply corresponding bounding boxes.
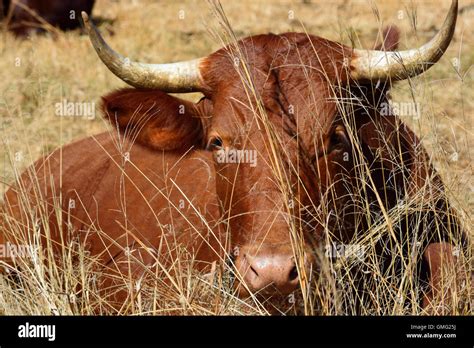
[350,0,458,81]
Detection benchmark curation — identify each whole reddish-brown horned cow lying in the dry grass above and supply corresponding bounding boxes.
[0,0,467,314]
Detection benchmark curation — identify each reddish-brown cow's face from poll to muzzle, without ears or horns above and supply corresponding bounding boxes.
[203,34,362,294]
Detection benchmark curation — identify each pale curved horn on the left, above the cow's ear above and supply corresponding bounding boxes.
[82,12,205,93]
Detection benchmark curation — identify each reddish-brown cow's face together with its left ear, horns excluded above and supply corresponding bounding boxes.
[100,34,392,296]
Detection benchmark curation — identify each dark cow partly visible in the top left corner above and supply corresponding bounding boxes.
[3,0,95,37]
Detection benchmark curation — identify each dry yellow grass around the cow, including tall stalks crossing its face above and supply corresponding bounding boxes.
[0,0,474,314]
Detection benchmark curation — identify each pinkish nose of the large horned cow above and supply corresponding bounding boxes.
[237,249,299,295]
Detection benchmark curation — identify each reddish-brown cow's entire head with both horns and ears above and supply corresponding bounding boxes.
[84,1,457,295]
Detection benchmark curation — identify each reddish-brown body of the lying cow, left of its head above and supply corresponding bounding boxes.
[0,133,222,278]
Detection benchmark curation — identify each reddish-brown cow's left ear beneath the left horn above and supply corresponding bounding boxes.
[102,88,204,150]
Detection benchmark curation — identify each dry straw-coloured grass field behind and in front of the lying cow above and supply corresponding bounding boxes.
[0,0,474,315]
